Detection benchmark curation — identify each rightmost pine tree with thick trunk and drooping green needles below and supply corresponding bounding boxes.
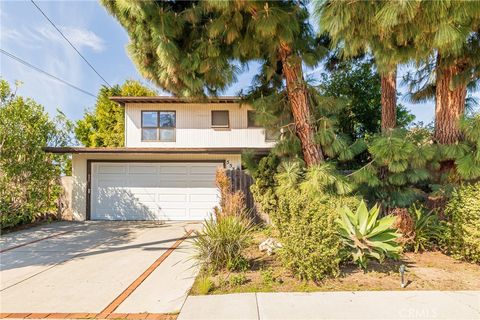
[377,0,480,144]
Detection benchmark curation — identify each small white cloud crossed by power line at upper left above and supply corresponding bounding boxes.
[38,26,105,52]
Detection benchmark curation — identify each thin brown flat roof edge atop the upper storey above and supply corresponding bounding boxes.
[110,96,242,106]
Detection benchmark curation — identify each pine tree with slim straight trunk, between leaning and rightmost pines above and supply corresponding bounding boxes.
[315,0,406,131]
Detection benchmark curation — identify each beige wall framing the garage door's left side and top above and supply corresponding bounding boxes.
[71,154,241,221]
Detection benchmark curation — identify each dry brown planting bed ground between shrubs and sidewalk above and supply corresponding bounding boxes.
[191,232,480,295]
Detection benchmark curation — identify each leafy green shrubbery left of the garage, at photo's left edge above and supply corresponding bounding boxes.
[0,79,71,229]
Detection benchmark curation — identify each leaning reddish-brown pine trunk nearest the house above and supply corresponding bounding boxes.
[279,45,324,166]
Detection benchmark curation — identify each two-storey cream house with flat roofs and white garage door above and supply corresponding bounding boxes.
[46,97,275,220]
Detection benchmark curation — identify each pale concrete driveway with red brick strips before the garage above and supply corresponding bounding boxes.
[0,222,201,317]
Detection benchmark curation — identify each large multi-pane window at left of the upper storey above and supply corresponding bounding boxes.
[142,111,176,142]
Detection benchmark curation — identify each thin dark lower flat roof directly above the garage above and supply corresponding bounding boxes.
[43,147,271,154]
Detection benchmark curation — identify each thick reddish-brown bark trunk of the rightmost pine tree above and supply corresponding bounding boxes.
[434,55,467,144]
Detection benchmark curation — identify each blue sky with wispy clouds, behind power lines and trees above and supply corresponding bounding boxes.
[0,1,462,123]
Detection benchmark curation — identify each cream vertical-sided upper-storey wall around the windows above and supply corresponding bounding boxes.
[125,103,275,148]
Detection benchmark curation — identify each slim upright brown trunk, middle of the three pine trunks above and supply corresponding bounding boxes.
[381,69,397,132]
